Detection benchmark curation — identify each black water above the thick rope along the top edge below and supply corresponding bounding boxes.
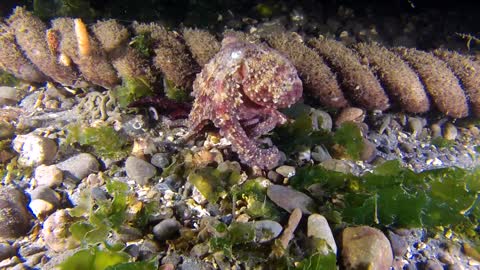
[0,0,480,49]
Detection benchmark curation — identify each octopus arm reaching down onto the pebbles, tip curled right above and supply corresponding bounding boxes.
[215,115,280,169]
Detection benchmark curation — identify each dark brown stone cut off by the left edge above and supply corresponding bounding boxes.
[0,187,32,241]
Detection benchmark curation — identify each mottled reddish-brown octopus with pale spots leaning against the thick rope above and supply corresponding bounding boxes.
[187,36,302,169]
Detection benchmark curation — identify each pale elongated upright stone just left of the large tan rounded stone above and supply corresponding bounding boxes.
[307,214,337,254]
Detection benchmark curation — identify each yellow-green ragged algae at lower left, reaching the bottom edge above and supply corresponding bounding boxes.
[59,179,158,270]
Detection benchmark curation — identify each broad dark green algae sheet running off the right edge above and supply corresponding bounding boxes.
[290,161,480,249]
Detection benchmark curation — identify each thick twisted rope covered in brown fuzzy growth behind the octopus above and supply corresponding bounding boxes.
[0,7,480,118]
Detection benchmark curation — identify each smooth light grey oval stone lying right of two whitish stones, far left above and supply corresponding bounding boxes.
[56,153,100,181]
